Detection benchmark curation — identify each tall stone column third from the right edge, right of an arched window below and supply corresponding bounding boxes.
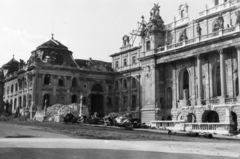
[197,55,202,105]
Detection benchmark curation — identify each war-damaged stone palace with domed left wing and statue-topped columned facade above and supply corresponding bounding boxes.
[0,0,240,132]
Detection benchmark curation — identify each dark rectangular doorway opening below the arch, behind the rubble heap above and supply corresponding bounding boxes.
[91,94,104,116]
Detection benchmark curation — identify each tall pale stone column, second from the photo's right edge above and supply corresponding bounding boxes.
[218,49,226,103]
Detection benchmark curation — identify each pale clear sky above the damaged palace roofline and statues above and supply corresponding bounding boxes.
[0,0,209,67]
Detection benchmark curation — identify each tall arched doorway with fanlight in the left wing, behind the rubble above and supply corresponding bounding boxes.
[91,84,104,116]
